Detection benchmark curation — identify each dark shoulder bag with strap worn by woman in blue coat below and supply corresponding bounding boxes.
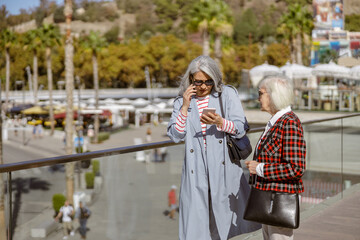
[219,94,252,163]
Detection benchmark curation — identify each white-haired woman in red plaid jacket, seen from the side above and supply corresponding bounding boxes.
[245,76,306,240]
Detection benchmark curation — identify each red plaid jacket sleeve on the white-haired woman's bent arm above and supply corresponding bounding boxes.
[264,119,306,181]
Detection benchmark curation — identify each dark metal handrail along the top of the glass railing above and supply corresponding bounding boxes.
[0,113,360,173]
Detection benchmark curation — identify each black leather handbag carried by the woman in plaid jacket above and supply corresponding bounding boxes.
[244,175,300,229]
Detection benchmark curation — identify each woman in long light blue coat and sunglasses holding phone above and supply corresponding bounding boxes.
[167,56,260,240]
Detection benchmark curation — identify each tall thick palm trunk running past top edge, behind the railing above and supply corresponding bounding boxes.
[64,0,75,203]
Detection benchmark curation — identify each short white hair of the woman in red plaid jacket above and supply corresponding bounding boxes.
[259,76,294,111]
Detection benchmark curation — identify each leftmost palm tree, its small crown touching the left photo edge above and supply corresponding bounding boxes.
[0,29,16,109]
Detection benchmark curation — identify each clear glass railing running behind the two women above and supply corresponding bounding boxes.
[0,114,360,240]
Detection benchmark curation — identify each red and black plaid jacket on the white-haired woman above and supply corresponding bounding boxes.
[255,112,306,193]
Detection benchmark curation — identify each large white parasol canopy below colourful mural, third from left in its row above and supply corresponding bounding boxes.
[312,62,350,78]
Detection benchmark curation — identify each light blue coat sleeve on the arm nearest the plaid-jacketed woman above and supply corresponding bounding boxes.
[224,86,248,138]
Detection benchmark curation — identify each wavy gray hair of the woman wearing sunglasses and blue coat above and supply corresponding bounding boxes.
[179,55,222,96]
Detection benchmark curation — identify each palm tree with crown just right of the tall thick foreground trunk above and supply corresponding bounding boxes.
[83,31,107,143]
